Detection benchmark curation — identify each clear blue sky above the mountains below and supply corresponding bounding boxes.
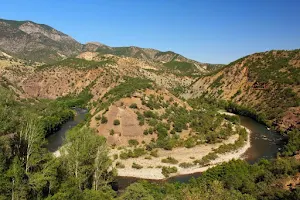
[0,0,300,63]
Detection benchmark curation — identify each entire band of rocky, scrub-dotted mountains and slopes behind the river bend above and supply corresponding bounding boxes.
[0,20,300,130]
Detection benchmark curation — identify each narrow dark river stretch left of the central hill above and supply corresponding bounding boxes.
[47,108,87,152]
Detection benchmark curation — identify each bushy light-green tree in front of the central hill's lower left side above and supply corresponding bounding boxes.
[62,127,112,190]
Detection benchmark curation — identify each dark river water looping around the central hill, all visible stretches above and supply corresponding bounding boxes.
[47,111,283,189]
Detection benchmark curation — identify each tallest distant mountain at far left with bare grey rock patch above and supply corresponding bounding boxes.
[0,19,82,62]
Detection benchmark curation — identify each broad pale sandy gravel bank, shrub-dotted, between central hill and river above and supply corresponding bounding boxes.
[110,125,251,180]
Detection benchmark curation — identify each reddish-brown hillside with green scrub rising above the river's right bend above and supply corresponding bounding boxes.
[188,49,300,130]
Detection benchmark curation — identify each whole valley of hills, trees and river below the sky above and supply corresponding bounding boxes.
[0,17,300,199]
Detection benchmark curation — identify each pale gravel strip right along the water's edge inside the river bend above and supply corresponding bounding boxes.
[113,126,251,180]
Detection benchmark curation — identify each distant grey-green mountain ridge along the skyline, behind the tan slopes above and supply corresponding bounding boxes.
[0,19,221,73]
